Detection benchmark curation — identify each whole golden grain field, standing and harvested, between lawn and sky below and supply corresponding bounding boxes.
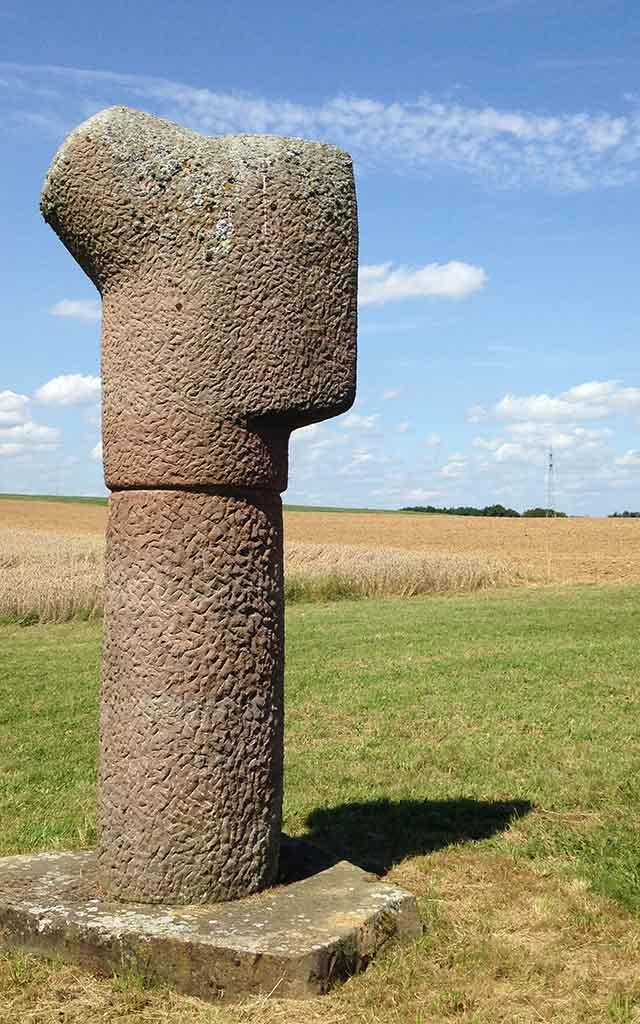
[0,499,640,623]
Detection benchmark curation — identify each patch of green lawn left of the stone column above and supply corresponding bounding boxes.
[0,623,100,853]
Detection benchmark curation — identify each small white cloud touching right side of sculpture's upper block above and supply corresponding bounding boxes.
[358,260,486,305]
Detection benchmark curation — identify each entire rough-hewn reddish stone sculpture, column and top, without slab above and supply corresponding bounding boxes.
[41,108,357,903]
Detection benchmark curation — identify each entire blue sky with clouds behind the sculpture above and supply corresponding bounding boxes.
[0,0,640,514]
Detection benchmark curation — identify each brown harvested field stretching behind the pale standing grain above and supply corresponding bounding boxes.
[0,499,640,583]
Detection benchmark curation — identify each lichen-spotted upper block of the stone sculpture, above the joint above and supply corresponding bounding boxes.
[41,106,357,489]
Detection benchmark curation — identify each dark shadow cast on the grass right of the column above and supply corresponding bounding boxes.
[285,799,534,874]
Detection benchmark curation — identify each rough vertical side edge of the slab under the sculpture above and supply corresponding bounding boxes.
[0,855,422,999]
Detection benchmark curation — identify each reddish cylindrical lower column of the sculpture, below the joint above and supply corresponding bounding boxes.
[98,490,284,902]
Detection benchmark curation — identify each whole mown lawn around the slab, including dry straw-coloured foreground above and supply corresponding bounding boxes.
[0,587,640,1024]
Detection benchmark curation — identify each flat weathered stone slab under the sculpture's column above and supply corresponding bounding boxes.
[0,852,422,998]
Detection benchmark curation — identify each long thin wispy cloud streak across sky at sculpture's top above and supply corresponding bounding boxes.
[0,63,640,189]
